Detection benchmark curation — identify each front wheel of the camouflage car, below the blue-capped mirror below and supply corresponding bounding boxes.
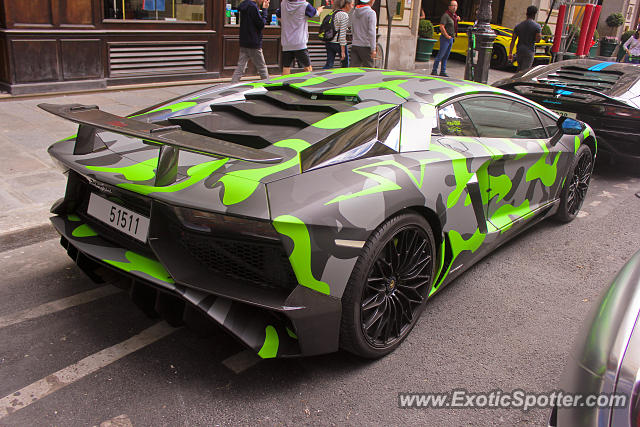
[556,144,593,222]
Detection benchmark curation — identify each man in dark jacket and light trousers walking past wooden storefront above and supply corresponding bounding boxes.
[231,0,269,83]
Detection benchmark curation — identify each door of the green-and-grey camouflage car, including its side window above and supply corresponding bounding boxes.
[460,95,562,230]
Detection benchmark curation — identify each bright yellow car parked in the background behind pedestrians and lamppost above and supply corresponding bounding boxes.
[433,22,552,68]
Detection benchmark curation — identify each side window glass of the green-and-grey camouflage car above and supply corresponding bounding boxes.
[460,96,547,139]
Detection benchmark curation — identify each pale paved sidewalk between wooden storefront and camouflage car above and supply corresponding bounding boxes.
[0,58,512,252]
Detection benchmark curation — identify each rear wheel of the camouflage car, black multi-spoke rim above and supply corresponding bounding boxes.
[340,213,437,359]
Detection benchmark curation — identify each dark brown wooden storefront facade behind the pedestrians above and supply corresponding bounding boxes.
[0,0,396,94]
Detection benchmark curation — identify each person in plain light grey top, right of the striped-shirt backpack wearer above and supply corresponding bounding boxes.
[351,0,377,67]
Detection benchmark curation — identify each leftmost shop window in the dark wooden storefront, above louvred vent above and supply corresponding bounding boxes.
[104,0,205,22]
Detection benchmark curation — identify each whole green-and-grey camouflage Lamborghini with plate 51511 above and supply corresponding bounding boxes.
[40,68,596,358]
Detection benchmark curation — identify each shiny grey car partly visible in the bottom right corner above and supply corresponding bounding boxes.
[549,251,640,427]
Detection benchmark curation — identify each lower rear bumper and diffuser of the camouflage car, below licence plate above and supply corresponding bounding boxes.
[51,215,341,358]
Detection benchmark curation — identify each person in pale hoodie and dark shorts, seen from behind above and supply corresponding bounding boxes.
[276,0,324,75]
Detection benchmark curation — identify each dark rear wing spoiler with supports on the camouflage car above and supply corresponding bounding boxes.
[38,104,282,167]
